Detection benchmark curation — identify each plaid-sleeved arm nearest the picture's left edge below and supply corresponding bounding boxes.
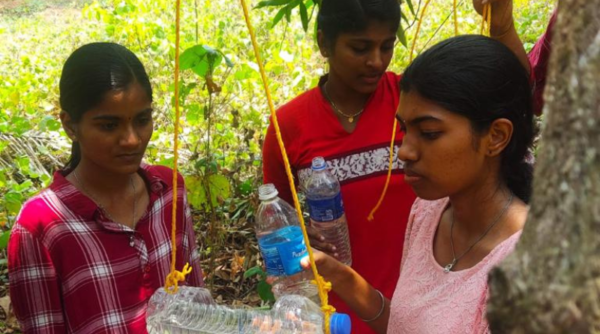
[8,222,66,334]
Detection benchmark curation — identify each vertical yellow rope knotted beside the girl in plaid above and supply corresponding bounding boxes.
[165,0,192,293]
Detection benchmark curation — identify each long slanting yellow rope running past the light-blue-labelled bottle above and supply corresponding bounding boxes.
[240,0,335,334]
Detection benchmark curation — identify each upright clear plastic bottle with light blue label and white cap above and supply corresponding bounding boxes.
[256,184,320,303]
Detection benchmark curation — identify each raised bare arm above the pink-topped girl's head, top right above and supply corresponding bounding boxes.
[473,0,531,73]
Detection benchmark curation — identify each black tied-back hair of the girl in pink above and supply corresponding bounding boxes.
[400,35,536,203]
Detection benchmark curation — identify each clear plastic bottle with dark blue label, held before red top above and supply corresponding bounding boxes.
[304,157,352,265]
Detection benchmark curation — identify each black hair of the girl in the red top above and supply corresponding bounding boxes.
[317,0,400,46]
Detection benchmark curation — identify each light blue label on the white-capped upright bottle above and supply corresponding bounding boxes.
[258,226,307,276]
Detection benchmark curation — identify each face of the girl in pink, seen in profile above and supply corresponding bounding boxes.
[396,91,497,200]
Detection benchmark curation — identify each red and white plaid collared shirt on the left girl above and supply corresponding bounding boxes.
[8,165,203,334]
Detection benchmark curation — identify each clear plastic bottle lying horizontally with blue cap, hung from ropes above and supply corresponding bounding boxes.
[146,286,351,334]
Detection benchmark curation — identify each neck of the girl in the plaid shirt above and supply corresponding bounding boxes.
[74,160,135,197]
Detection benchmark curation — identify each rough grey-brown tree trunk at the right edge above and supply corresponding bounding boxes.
[488,0,600,334]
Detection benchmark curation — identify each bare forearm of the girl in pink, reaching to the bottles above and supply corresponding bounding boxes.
[302,252,390,334]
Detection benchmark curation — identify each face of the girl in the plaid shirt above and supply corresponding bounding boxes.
[63,82,153,174]
